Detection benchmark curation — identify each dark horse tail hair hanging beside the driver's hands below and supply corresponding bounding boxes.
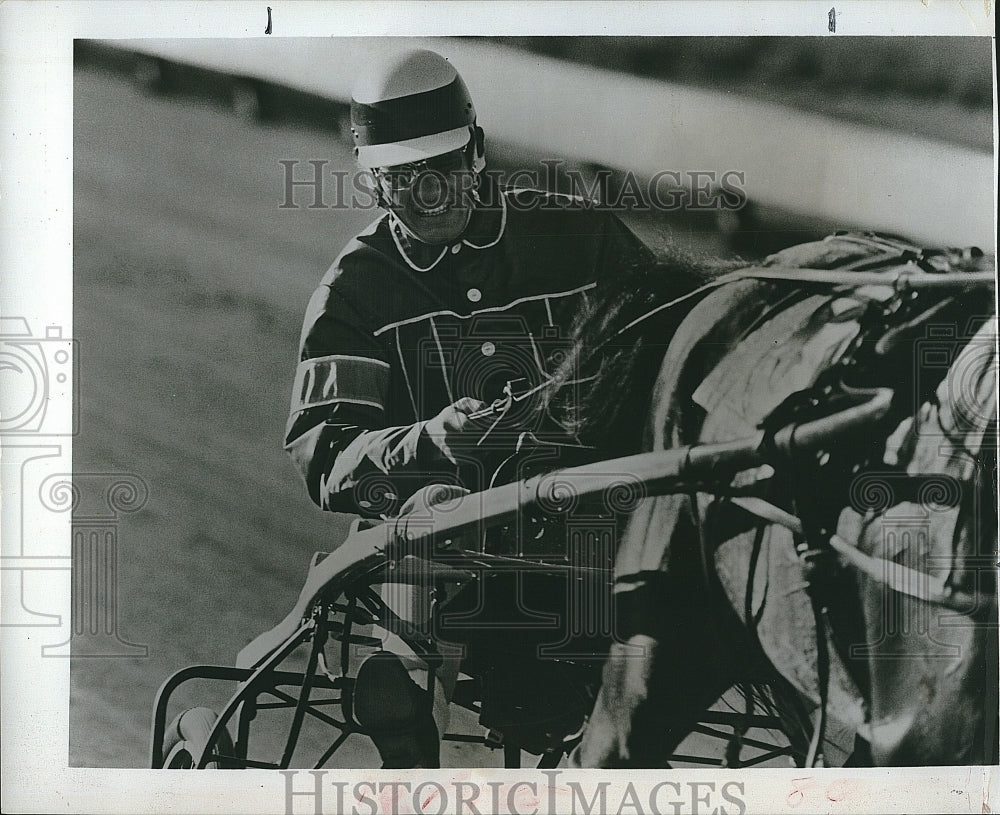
[548,248,743,455]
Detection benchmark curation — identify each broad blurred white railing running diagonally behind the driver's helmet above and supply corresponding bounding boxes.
[115,38,996,252]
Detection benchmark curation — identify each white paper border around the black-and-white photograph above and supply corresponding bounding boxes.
[0,0,1000,813]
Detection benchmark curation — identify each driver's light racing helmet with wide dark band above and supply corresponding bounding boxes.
[351,49,486,173]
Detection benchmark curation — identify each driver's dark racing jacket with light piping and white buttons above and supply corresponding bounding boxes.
[285,190,650,517]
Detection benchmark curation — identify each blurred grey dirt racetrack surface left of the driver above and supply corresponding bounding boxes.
[70,60,784,767]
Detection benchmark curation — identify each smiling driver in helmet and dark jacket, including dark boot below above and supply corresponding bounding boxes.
[285,50,650,767]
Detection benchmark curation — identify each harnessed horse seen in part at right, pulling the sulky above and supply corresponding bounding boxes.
[546,234,998,767]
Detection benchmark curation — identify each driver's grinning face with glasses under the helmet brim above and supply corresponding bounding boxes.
[378,148,475,245]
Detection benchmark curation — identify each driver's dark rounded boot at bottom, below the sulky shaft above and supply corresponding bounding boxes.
[353,651,441,770]
